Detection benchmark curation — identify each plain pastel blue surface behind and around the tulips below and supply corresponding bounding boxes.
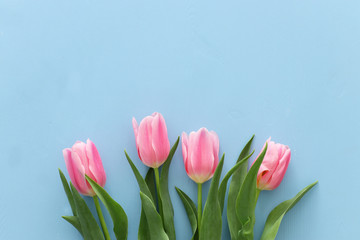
[0,0,360,240]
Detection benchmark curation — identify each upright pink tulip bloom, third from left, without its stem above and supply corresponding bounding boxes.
[181,128,219,183]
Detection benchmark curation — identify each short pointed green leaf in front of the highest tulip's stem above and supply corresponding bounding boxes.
[140,191,169,240]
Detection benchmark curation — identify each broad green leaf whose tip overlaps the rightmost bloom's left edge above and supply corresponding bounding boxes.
[236,143,267,240]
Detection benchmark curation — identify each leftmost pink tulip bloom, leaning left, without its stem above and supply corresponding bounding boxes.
[63,139,106,196]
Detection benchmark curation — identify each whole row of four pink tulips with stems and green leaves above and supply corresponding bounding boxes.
[59,113,317,240]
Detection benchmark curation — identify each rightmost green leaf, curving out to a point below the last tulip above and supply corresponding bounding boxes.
[261,181,318,240]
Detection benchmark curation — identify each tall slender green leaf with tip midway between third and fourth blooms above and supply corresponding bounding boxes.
[227,135,254,240]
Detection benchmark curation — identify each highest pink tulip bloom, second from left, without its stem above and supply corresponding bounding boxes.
[132,112,170,168]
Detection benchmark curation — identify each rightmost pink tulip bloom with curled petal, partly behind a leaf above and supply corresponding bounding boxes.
[255,137,291,190]
